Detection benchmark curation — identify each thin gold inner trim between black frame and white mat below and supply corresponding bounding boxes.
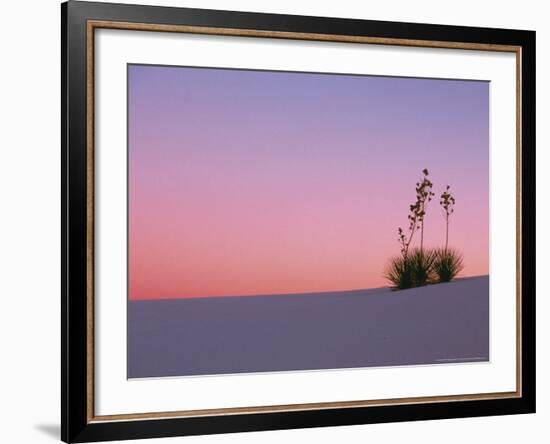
[86,20,522,423]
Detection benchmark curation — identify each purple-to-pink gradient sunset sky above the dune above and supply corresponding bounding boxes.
[128,65,489,300]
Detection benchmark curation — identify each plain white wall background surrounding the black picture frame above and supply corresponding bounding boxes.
[0,0,550,444]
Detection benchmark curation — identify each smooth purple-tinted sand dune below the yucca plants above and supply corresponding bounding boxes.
[128,276,489,378]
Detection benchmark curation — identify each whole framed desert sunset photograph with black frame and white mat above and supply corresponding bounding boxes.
[61,1,535,442]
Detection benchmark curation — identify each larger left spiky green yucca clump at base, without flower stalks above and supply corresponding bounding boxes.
[385,248,436,290]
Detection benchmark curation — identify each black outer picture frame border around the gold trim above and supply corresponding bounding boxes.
[61,1,536,442]
